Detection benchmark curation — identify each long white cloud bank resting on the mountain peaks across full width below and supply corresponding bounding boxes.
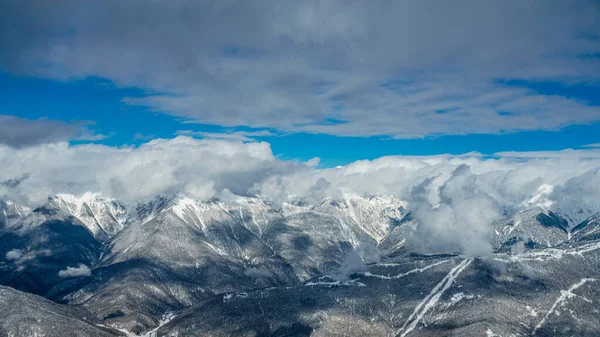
[0,136,600,256]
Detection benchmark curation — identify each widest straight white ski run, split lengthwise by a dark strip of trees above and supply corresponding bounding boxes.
[397,259,473,337]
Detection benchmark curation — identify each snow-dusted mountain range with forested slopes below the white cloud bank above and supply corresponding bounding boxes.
[0,193,600,336]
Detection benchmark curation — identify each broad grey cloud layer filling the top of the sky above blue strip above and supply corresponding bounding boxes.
[0,0,600,138]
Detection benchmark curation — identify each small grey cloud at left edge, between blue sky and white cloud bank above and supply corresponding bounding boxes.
[0,115,106,148]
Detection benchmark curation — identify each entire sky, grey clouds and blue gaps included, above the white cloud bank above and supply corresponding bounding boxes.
[0,1,600,167]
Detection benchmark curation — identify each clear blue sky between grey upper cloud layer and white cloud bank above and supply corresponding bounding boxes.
[0,73,600,167]
